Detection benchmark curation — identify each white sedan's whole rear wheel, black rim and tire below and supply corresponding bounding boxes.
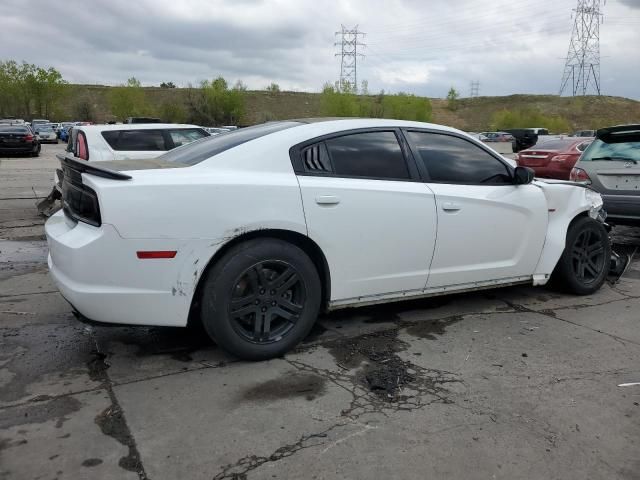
[201,238,321,360]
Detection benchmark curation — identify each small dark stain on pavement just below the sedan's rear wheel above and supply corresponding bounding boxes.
[242,373,327,401]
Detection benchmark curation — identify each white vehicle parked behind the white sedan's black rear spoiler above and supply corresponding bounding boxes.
[70,123,209,162]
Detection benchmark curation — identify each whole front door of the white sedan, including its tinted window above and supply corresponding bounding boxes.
[406,130,548,288]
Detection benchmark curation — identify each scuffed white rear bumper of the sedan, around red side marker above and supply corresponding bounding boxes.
[45,211,191,326]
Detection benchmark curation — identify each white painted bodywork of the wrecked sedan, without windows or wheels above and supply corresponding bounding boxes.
[46,119,601,326]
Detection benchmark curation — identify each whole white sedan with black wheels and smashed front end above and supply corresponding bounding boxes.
[46,119,611,359]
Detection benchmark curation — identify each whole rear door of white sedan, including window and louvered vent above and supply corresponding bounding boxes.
[291,129,436,301]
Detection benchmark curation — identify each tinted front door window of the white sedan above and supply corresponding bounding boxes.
[408,132,511,184]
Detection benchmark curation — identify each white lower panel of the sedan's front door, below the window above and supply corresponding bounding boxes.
[426,183,548,288]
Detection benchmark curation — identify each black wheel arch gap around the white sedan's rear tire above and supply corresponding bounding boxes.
[187,229,331,325]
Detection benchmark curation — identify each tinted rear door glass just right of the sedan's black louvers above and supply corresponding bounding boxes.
[325,132,410,180]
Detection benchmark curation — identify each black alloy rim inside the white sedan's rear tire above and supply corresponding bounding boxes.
[229,260,306,345]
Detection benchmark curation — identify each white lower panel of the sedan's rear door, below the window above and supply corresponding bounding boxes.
[299,176,436,299]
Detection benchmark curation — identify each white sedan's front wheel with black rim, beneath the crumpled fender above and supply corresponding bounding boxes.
[554,217,611,295]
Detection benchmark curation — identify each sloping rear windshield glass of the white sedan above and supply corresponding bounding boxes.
[158,122,301,165]
